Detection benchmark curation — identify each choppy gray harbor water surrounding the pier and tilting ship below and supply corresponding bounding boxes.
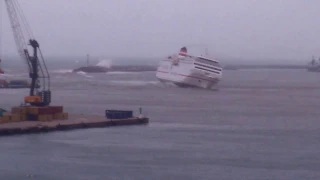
[0,65,320,180]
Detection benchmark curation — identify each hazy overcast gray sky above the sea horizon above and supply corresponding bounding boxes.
[1,0,320,61]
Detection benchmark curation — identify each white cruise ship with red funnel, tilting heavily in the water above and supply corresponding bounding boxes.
[156,47,222,89]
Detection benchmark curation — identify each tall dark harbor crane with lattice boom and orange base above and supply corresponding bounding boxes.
[4,0,51,106]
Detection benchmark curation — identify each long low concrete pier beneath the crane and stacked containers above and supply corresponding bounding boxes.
[0,114,149,136]
